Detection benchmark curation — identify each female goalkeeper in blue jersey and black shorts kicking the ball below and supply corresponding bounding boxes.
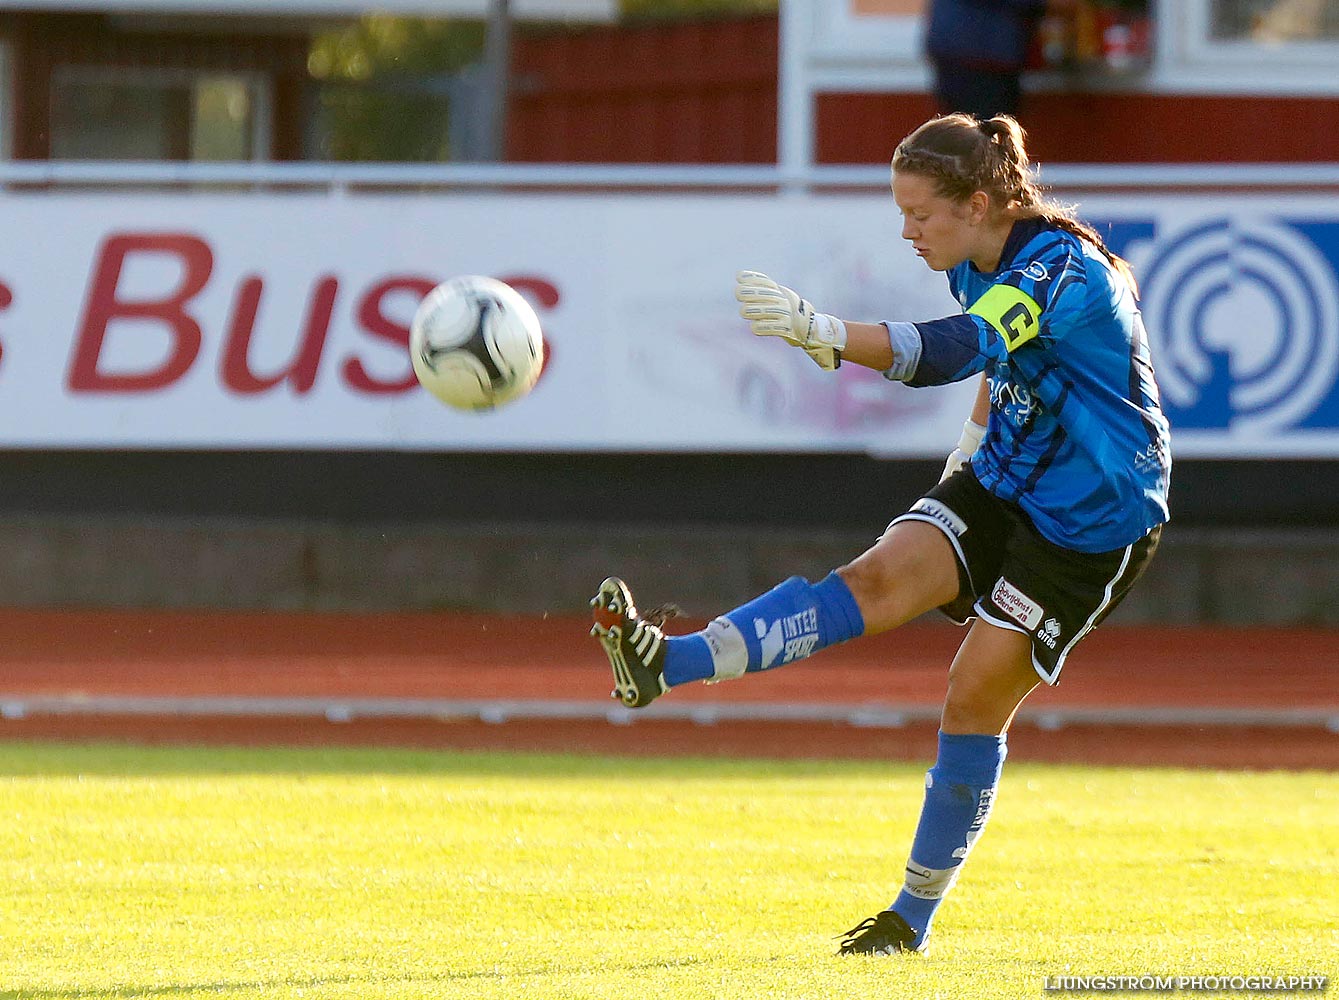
[592,114,1170,954]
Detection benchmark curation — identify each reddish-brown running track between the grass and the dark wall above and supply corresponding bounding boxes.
[0,610,1339,770]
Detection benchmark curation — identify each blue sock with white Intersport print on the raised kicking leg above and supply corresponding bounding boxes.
[663,573,865,687]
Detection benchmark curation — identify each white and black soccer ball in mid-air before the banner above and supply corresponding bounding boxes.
[410,274,544,410]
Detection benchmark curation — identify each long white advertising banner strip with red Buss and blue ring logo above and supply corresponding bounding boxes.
[0,193,1339,456]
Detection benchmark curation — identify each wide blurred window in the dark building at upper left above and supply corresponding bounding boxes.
[51,66,268,161]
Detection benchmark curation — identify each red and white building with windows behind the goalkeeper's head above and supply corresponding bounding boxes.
[781,0,1339,167]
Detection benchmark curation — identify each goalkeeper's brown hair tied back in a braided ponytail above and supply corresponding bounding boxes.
[893,114,1138,295]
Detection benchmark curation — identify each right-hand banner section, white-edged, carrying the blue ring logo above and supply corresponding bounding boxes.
[1110,206,1339,458]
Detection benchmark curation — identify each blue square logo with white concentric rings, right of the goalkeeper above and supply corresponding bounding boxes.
[1110,217,1339,431]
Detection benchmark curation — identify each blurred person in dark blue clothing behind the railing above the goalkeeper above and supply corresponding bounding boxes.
[925,0,1075,120]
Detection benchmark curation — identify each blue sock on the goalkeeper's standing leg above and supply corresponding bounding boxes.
[889,732,1008,948]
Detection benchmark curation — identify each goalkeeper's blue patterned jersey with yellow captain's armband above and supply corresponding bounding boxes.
[907,220,1172,552]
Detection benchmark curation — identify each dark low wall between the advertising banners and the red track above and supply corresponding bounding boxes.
[0,452,1339,625]
